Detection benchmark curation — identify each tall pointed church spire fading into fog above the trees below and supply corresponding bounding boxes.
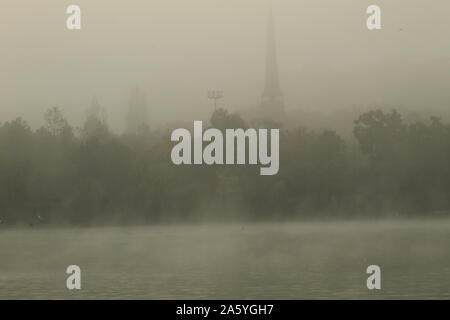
[261,8,284,120]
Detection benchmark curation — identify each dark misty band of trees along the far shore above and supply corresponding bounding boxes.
[0,107,450,225]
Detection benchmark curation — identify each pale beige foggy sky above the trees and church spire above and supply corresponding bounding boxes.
[0,0,450,130]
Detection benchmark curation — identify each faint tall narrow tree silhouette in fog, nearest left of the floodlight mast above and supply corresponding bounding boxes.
[125,86,148,133]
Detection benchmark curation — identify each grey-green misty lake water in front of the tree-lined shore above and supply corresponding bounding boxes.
[0,220,450,299]
